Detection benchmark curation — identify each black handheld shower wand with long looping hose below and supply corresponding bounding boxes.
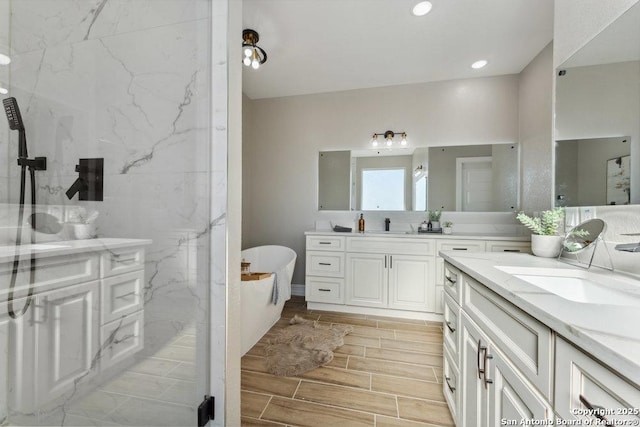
[2,97,47,319]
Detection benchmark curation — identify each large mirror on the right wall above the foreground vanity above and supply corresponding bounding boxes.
[555,3,640,206]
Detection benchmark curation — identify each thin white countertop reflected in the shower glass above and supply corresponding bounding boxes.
[0,238,152,263]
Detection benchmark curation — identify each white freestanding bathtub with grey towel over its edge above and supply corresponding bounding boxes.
[238,245,297,355]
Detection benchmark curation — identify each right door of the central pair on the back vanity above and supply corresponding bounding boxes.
[388,255,435,312]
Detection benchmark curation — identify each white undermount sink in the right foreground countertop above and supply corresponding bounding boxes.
[496,266,640,307]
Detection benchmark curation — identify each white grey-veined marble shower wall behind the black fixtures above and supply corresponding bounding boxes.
[5,0,211,374]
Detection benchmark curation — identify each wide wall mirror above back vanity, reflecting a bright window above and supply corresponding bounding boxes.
[318,143,520,212]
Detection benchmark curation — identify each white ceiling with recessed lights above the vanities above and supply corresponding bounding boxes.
[238,0,553,99]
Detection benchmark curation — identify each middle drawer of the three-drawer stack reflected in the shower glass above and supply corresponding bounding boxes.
[101,270,144,324]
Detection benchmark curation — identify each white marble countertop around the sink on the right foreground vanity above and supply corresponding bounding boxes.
[440,251,640,387]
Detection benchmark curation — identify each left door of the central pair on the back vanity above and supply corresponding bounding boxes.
[346,253,388,307]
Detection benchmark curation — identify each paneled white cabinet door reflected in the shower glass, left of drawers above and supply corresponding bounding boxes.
[33,281,100,405]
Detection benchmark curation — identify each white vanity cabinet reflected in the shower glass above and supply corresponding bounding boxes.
[0,239,146,412]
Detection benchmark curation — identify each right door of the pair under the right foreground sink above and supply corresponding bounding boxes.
[485,347,554,426]
